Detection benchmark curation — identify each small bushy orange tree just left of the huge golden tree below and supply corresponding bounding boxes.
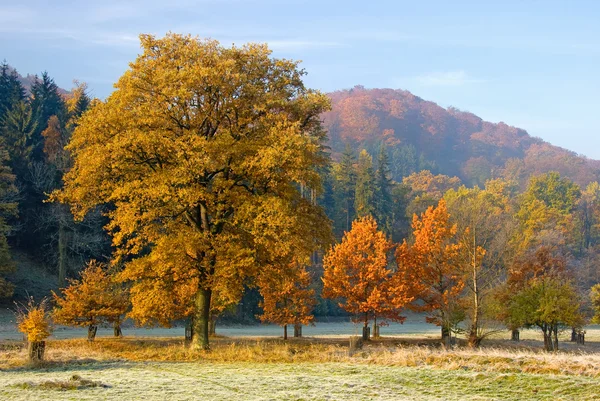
[52,261,129,341]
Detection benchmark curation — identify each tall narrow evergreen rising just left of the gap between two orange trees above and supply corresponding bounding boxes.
[375,143,393,235]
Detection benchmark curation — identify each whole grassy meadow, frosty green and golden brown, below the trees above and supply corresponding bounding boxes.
[0,310,600,400]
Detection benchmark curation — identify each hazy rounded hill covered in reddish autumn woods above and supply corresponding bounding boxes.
[323,86,600,185]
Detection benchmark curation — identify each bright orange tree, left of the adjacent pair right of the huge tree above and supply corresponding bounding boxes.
[323,216,411,338]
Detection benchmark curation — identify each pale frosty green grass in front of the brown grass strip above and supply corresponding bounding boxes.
[0,362,600,401]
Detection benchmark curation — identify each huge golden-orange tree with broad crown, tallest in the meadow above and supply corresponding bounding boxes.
[54,34,329,348]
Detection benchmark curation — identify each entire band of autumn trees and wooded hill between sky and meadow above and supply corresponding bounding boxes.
[0,34,600,359]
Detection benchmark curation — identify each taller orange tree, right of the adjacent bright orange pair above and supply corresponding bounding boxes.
[396,199,465,340]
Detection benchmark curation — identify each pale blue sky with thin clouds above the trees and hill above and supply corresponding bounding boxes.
[0,0,600,159]
